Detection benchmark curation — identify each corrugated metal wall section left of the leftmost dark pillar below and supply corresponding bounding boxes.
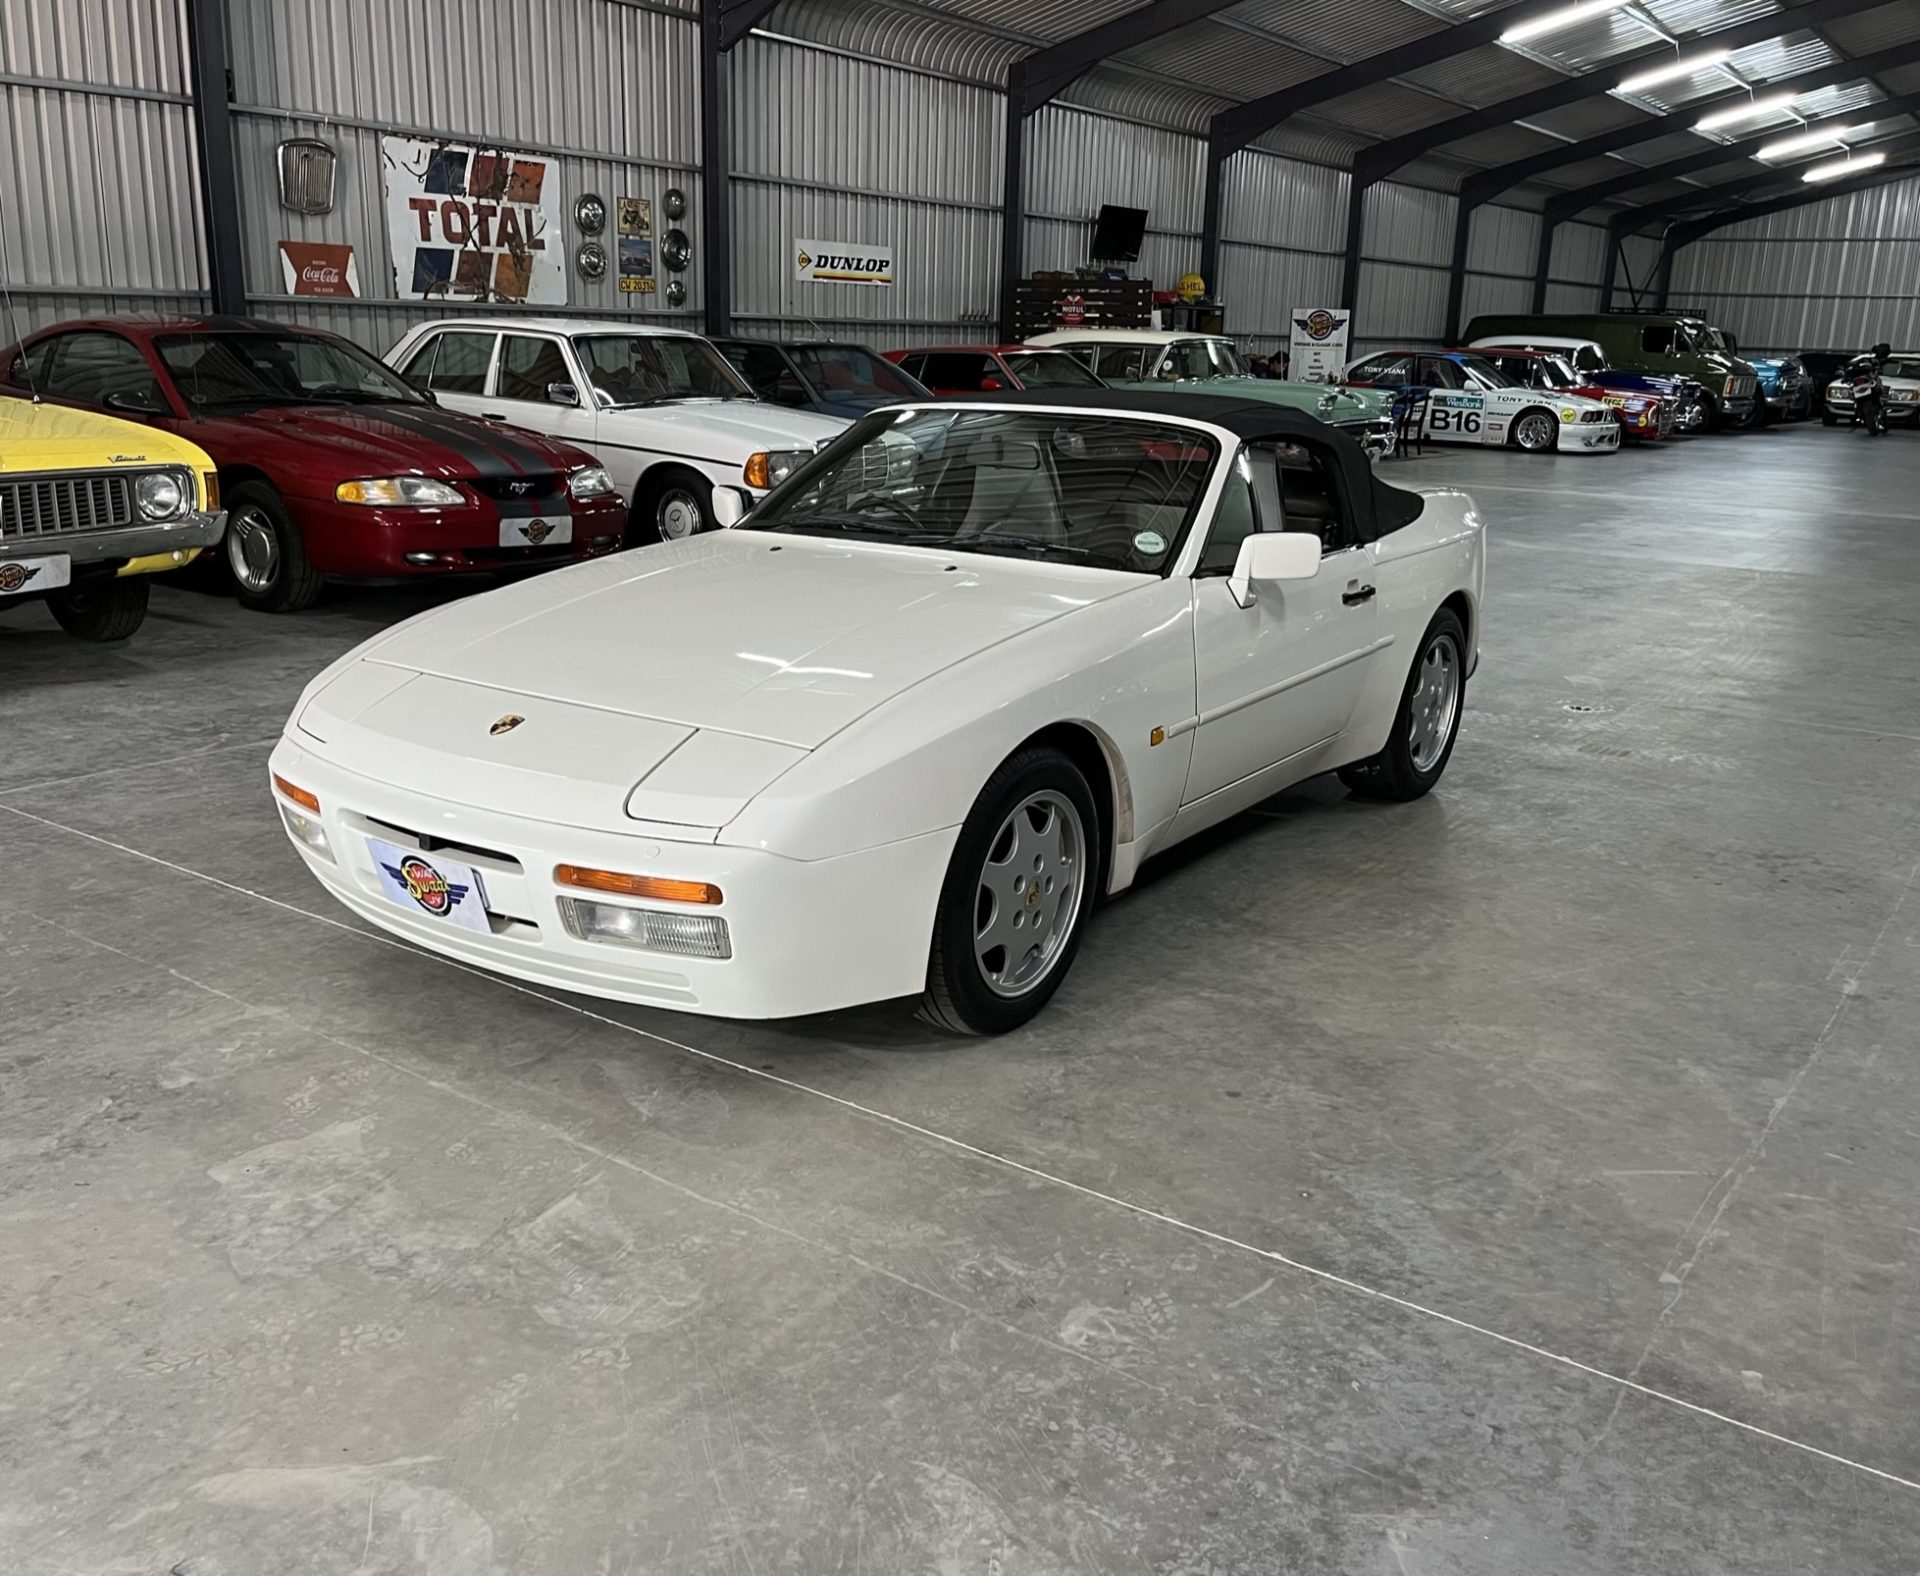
[0,0,205,328]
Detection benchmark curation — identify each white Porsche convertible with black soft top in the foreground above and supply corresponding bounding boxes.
[271,390,1484,1033]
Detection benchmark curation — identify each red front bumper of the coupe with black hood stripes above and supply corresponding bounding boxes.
[288,495,626,580]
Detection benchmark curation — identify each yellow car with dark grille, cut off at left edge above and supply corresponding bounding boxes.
[0,399,227,641]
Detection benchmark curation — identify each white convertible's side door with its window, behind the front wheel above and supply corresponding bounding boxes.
[1185,440,1379,812]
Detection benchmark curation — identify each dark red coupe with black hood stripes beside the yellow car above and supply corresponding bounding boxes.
[0,317,626,612]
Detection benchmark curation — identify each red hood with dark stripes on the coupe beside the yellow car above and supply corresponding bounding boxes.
[179,405,593,480]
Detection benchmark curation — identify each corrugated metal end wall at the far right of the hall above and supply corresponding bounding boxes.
[1672,180,1920,351]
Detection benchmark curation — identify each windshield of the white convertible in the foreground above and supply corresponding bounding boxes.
[747,407,1217,574]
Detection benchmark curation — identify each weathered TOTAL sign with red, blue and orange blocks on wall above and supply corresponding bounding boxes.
[380,136,566,305]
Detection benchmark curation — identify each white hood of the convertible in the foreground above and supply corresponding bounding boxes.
[341,530,1148,749]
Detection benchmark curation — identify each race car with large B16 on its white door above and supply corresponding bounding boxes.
[1342,349,1620,455]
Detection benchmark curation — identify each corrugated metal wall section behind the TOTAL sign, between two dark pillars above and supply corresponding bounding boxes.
[223,0,701,351]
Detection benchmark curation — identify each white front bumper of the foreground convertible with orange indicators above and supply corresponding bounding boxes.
[267,739,960,1017]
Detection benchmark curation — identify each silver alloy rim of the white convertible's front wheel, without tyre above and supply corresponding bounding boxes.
[973,789,1087,996]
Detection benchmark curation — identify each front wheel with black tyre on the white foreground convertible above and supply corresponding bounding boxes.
[920,749,1106,1035]
